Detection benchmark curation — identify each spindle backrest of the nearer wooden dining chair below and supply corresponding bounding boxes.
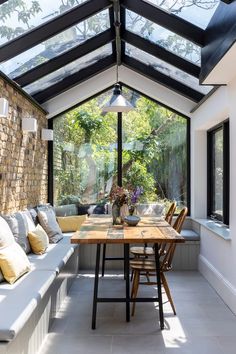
[160,207,188,272]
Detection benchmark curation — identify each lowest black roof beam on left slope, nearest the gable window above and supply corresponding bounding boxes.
[33,54,116,103]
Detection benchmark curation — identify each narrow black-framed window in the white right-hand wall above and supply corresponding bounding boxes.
[208,121,229,225]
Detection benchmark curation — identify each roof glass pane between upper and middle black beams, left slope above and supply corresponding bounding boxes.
[0,10,110,78]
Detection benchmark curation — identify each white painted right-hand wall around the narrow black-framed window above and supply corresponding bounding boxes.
[191,80,236,313]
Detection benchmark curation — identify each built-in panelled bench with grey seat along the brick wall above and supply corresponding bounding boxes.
[0,233,78,354]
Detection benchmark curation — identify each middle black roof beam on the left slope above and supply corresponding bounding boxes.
[13,29,114,86]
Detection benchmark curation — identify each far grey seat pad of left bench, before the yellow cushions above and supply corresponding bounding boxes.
[28,244,74,273]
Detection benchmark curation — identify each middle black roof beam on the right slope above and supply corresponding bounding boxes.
[122,30,200,78]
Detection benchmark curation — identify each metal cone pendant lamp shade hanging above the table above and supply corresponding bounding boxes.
[102,83,134,112]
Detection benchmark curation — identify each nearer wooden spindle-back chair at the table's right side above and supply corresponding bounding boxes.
[130,207,188,316]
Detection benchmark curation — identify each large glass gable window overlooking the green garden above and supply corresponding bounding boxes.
[53,87,189,209]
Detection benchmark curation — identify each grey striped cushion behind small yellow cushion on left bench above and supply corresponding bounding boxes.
[3,210,35,253]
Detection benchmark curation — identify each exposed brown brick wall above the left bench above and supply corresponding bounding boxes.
[0,77,48,213]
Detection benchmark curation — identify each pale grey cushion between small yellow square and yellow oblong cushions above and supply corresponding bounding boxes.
[38,209,63,243]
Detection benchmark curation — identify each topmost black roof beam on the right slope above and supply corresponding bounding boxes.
[122,0,204,47]
